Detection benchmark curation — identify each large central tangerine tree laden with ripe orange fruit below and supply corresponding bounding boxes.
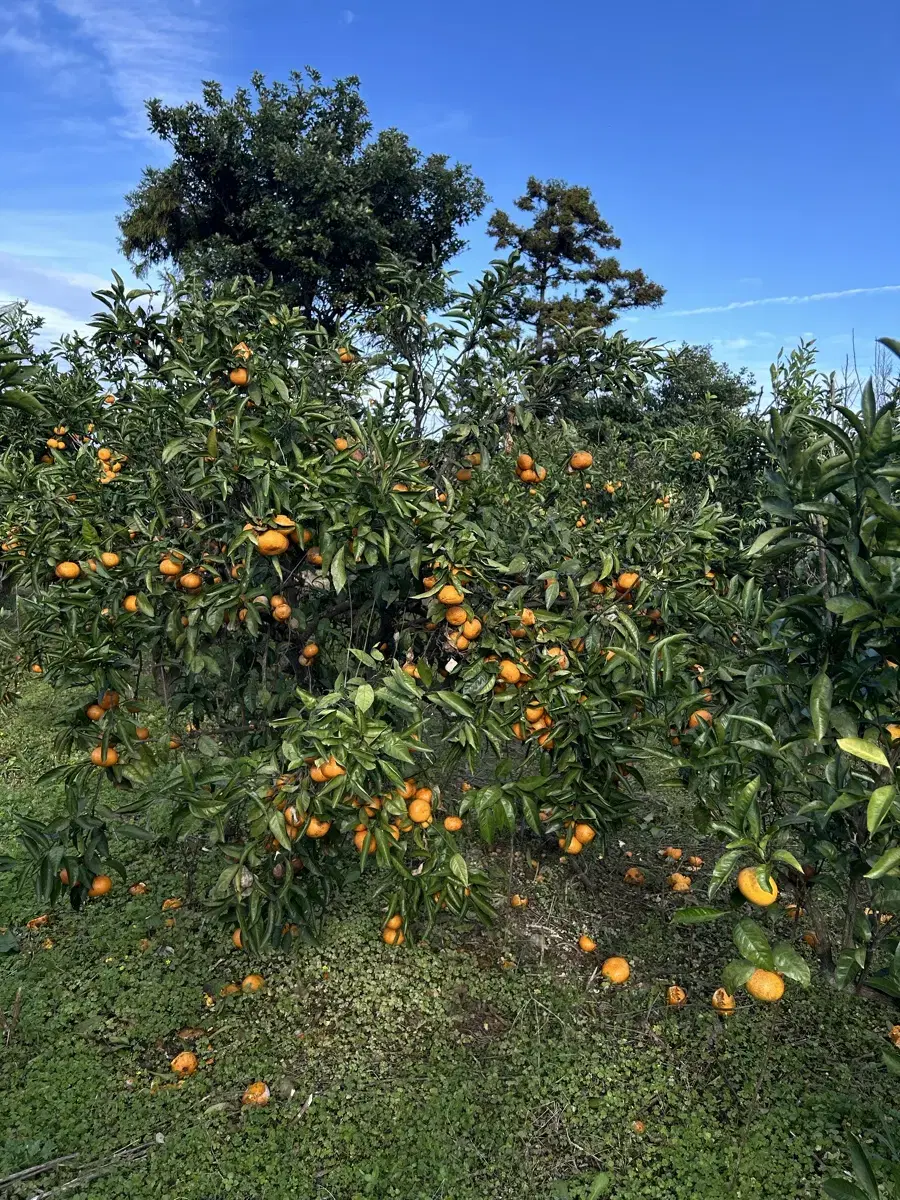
[0,266,731,948]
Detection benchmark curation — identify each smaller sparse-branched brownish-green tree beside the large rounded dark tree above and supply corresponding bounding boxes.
[487,176,665,355]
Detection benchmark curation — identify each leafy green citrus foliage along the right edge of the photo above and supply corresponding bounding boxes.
[676,338,900,997]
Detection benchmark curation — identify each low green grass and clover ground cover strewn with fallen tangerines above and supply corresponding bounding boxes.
[0,685,892,1200]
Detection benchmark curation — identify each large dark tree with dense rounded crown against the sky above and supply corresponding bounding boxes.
[119,70,486,326]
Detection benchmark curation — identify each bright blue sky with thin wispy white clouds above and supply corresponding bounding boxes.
[0,0,900,380]
